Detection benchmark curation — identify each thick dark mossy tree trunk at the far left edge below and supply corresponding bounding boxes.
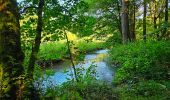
[0,0,24,100]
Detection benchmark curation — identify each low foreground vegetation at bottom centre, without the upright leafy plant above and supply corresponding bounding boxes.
[43,80,119,100]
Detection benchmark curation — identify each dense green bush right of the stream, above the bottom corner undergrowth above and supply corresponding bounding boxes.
[110,41,170,83]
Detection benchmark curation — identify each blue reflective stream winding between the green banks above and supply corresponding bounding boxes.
[40,49,114,85]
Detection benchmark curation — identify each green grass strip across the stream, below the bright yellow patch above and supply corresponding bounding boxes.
[38,40,106,61]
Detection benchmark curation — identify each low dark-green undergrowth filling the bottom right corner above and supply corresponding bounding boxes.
[117,83,170,100]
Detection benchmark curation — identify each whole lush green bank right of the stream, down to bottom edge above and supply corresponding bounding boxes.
[110,41,170,100]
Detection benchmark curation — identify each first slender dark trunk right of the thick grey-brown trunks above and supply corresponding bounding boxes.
[143,0,147,42]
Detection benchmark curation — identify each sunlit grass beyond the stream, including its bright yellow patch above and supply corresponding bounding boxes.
[38,31,110,61]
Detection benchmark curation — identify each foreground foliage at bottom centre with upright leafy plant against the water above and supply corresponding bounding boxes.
[42,64,118,100]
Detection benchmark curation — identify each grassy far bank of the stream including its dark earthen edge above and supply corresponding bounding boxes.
[37,41,106,68]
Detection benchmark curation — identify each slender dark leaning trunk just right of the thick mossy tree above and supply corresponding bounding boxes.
[28,0,44,98]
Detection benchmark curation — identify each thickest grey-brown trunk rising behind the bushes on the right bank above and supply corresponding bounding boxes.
[121,0,129,44]
